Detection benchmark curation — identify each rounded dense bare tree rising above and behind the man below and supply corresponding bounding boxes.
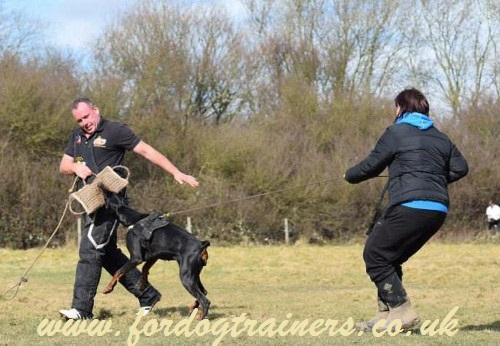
[91,0,244,126]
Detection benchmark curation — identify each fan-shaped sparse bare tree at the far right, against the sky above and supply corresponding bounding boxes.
[414,0,498,115]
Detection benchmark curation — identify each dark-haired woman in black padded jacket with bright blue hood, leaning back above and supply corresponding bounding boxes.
[344,88,468,330]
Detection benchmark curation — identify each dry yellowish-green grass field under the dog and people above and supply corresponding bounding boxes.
[0,242,500,345]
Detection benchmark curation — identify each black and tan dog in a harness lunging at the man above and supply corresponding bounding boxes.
[103,191,210,320]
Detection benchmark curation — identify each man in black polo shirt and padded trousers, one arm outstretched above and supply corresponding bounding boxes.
[59,98,198,319]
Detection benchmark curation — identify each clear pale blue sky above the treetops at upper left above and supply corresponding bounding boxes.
[0,0,243,55]
